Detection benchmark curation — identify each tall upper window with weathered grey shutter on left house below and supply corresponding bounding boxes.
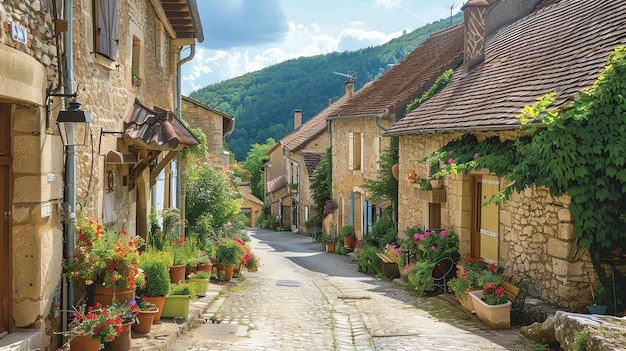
[94,0,117,60]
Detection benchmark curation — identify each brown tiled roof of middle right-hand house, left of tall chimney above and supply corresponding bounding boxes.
[330,24,463,117]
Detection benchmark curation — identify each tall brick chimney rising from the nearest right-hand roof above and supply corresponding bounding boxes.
[461,0,489,73]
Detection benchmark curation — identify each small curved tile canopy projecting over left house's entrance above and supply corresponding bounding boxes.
[124,101,200,149]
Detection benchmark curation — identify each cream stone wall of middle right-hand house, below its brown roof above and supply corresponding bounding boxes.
[325,118,390,240]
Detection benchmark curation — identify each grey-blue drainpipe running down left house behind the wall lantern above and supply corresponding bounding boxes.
[62,0,76,330]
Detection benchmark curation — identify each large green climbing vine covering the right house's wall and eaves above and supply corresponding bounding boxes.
[421,47,626,262]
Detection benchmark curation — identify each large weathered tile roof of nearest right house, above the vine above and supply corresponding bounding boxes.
[385,0,626,135]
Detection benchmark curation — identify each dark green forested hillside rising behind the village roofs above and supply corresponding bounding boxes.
[190,12,463,161]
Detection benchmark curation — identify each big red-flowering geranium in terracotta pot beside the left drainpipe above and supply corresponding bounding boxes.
[65,217,142,306]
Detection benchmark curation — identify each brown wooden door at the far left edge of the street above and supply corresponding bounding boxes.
[0,104,12,333]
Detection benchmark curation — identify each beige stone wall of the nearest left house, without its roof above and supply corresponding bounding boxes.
[0,0,199,349]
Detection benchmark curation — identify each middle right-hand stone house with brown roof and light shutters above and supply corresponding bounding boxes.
[327,24,463,240]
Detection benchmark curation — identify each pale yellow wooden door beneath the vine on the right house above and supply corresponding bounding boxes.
[472,175,500,263]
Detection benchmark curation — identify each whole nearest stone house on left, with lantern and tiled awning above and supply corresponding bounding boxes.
[0,0,202,350]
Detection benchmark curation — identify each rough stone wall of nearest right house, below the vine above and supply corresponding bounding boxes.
[398,132,594,311]
